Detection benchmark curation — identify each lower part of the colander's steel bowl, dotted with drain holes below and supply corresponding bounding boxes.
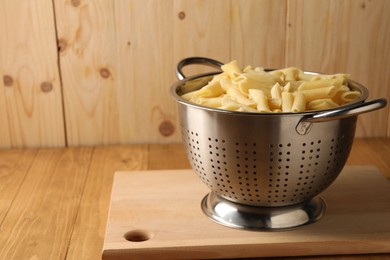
[182,115,352,207]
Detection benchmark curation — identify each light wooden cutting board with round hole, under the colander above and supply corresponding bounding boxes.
[103,166,390,260]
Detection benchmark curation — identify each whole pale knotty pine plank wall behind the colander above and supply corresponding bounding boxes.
[0,0,390,148]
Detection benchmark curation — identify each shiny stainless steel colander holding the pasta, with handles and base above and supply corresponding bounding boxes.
[171,57,386,229]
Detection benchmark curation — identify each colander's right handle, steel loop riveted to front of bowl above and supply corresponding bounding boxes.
[295,98,387,135]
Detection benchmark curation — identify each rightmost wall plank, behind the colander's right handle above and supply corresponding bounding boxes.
[286,0,390,137]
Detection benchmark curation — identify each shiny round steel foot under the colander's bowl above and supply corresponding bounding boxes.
[201,192,326,231]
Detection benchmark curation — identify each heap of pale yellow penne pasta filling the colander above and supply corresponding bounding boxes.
[182,61,361,113]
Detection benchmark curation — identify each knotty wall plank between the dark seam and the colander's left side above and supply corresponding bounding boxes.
[56,0,178,145]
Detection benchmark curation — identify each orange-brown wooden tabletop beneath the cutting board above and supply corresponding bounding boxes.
[0,138,390,260]
